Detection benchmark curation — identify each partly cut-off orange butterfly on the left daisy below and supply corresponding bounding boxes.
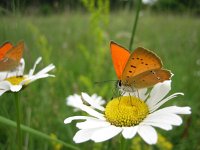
[0,42,24,71]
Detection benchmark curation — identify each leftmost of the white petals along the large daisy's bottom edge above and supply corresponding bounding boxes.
[73,129,97,143]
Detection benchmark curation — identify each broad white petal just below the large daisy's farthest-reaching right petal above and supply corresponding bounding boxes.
[145,112,182,126]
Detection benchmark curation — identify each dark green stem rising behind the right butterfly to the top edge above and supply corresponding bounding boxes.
[129,0,142,50]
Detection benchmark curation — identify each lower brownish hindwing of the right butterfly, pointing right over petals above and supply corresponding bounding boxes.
[130,69,172,89]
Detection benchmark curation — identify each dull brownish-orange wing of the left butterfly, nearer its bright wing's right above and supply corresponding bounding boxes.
[0,42,24,71]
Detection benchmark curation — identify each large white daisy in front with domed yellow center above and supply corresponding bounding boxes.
[64,81,191,144]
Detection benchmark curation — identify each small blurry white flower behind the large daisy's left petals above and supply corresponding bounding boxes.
[66,93,106,111]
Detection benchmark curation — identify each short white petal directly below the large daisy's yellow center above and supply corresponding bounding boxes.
[122,126,138,139]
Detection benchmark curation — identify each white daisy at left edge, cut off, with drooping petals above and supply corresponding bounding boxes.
[0,57,55,96]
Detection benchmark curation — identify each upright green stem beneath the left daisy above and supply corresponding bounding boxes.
[14,92,22,150]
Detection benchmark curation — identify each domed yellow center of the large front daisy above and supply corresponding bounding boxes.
[105,96,149,127]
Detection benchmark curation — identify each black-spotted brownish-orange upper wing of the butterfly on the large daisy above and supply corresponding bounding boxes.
[122,47,162,85]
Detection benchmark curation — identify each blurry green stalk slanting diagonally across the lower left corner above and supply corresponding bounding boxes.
[0,116,80,150]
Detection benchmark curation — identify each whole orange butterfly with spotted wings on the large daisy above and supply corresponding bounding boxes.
[110,41,172,92]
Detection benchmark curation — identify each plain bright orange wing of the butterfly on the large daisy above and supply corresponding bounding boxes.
[110,41,130,80]
